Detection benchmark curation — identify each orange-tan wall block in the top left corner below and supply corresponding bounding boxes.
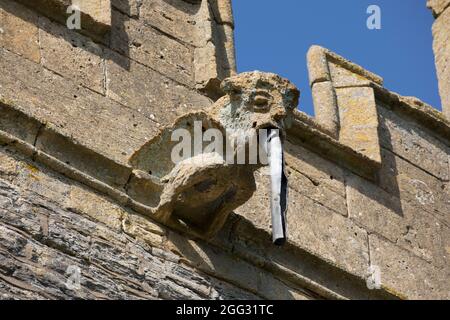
[0,0,41,63]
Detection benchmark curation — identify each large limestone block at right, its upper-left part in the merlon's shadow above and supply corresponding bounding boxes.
[347,172,443,266]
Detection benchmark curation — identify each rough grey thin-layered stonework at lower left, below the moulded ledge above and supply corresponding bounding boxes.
[0,152,270,299]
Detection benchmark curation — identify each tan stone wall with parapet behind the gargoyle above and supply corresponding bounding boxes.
[0,0,450,299]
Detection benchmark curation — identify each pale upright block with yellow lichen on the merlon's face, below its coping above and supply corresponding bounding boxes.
[336,87,381,162]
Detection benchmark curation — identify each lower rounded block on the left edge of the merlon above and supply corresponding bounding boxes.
[312,81,339,138]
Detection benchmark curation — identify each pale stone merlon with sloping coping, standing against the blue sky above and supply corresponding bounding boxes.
[308,46,383,163]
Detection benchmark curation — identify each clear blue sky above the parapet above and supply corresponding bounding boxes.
[233,0,441,114]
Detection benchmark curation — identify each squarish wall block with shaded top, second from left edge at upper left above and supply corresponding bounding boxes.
[39,17,105,94]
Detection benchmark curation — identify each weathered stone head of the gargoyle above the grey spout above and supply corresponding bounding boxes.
[222,72,300,129]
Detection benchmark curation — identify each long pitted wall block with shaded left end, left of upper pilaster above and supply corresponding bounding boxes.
[111,12,194,87]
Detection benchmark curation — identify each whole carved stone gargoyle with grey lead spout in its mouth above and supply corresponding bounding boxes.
[128,72,300,245]
